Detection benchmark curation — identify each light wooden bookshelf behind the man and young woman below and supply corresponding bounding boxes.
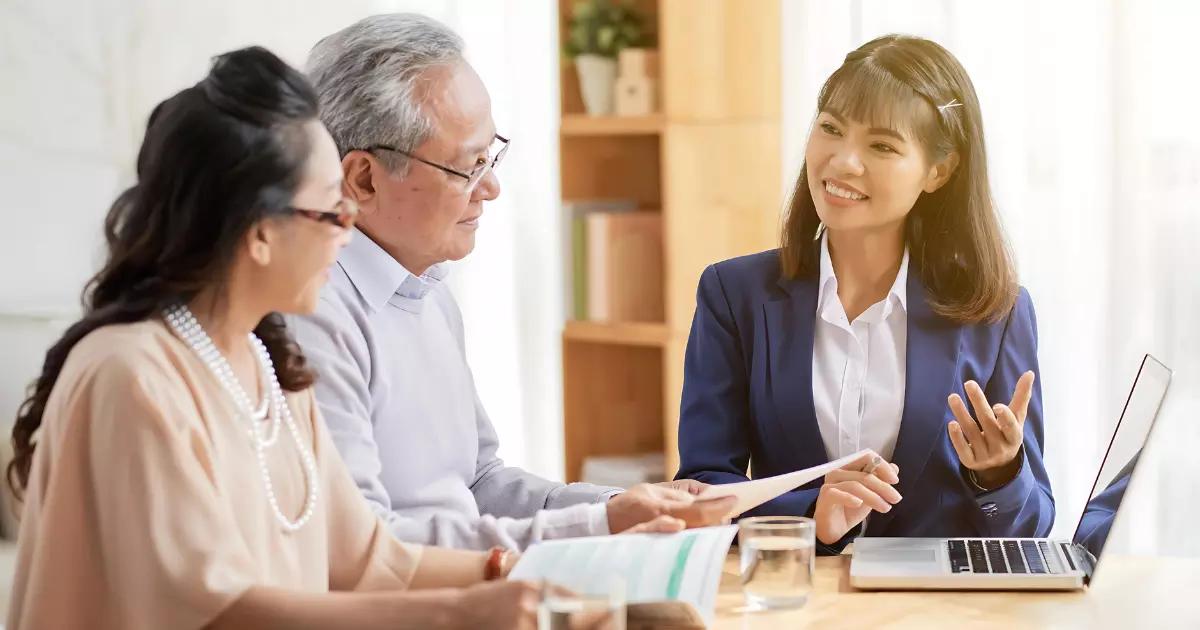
[557,0,782,481]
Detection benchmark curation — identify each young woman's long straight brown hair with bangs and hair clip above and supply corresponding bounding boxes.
[780,35,1018,323]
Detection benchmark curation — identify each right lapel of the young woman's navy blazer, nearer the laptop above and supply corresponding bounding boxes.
[870,268,962,532]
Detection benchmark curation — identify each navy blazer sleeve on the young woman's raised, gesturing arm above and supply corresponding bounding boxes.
[976,288,1055,538]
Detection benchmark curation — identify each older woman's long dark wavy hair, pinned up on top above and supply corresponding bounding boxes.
[7,47,317,496]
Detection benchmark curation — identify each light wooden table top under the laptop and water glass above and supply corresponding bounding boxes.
[712,547,1200,630]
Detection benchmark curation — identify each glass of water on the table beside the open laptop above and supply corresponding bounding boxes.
[738,516,816,608]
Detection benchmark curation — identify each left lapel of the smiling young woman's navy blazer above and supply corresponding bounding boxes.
[763,278,828,468]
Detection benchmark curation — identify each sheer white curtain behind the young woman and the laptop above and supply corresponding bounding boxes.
[781,0,1200,554]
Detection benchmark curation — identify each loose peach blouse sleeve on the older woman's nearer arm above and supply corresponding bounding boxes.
[81,348,262,629]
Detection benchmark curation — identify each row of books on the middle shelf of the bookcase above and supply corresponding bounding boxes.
[565,200,664,323]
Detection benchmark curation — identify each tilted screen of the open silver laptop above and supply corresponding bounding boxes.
[1074,354,1171,559]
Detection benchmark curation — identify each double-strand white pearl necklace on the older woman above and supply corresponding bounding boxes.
[163,305,317,532]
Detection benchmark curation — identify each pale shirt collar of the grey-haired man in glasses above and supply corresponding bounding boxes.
[337,228,450,312]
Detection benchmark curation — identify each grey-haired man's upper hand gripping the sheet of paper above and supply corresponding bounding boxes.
[608,484,737,533]
